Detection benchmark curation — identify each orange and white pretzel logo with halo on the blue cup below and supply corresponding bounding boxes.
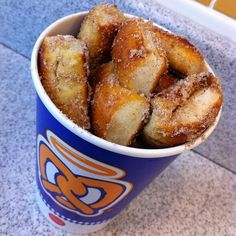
[37,130,133,217]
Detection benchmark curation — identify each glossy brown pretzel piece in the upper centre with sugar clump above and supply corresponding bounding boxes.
[112,19,168,96]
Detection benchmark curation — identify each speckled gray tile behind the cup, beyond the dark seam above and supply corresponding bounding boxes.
[0,0,236,172]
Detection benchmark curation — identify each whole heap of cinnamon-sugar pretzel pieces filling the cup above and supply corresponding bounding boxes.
[39,4,222,148]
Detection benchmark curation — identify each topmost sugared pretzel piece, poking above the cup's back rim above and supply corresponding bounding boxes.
[78,4,125,71]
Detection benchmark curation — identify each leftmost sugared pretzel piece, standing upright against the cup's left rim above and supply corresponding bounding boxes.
[39,35,90,129]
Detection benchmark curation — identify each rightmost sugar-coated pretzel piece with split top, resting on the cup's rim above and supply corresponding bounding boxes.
[143,72,222,147]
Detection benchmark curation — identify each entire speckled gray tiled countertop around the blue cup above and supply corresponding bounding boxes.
[0,0,236,236]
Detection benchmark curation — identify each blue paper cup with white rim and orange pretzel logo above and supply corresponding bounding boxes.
[31,12,220,233]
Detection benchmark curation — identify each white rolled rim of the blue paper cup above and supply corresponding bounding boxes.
[31,11,222,158]
